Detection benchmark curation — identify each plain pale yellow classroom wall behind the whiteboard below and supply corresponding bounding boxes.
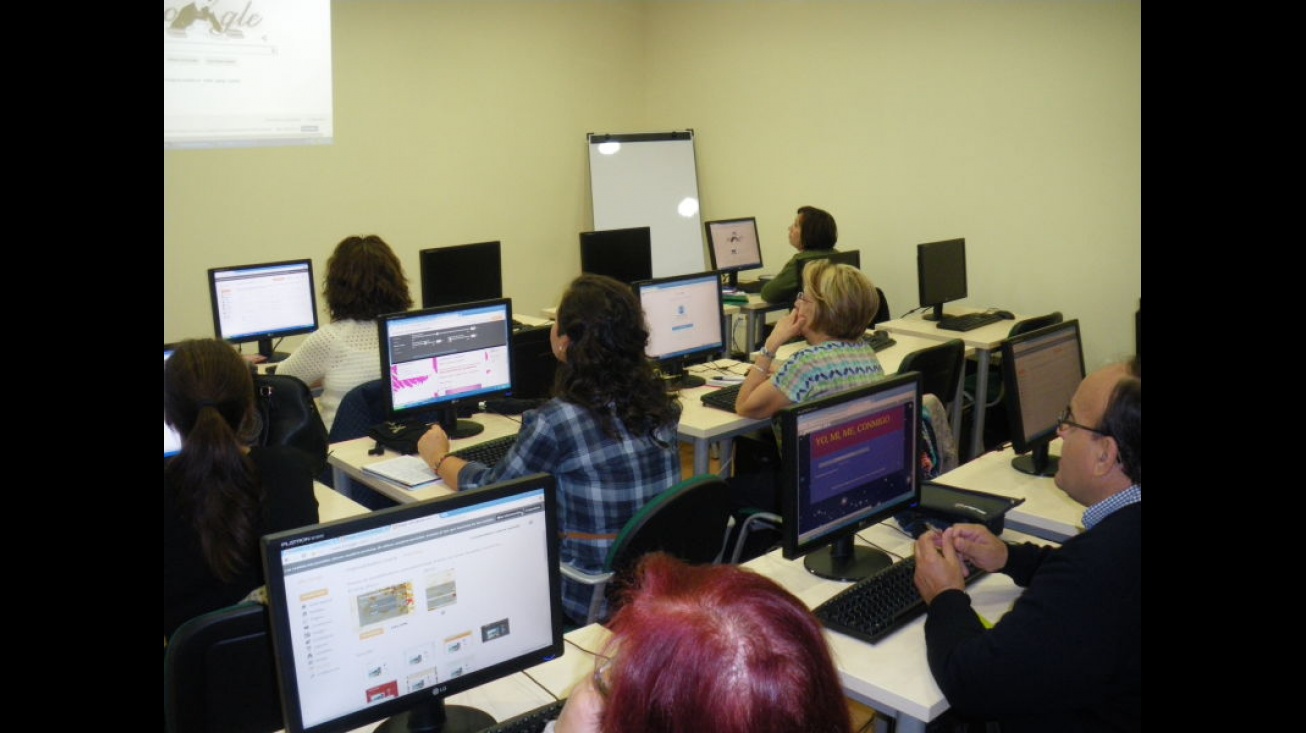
[163,0,1141,368]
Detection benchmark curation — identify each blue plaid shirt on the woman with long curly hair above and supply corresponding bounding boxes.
[458,400,680,622]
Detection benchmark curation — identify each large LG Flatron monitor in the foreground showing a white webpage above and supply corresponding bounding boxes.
[261,474,563,733]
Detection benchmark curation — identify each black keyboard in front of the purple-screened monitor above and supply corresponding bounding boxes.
[812,557,987,644]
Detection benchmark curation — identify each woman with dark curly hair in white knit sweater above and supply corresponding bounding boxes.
[277,234,413,430]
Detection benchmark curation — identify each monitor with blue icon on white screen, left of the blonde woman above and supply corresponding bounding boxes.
[635,272,726,391]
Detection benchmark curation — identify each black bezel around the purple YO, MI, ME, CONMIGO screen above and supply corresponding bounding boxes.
[777,371,922,559]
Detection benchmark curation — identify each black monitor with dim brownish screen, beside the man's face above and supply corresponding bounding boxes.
[1000,320,1084,476]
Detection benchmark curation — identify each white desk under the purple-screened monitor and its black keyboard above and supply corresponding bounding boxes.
[743,523,1033,733]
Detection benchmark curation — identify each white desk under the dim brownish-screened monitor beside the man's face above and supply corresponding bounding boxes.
[938,438,1084,542]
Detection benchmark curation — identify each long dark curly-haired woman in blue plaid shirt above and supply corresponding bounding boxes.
[418,274,680,623]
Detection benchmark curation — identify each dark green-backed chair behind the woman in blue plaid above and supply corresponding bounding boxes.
[562,473,730,623]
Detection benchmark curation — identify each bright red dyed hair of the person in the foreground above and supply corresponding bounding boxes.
[602,553,852,733]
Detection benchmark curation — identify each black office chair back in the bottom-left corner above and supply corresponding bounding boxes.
[163,601,285,733]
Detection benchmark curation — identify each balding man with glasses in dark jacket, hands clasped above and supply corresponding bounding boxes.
[916,358,1143,733]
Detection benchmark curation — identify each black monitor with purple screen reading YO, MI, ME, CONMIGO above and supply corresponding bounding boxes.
[778,371,921,580]
